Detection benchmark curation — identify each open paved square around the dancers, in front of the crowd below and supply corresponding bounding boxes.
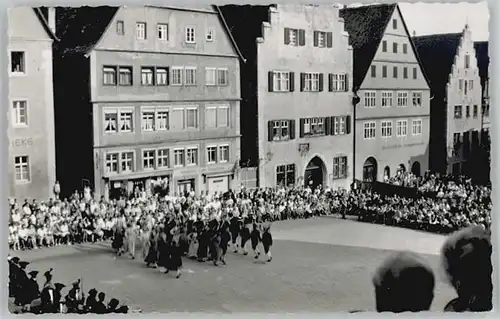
[11,217,453,313]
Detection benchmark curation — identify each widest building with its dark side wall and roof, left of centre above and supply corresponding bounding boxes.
[52,6,242,197]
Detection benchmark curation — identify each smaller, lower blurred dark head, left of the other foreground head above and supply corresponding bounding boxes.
[373,252,435,312]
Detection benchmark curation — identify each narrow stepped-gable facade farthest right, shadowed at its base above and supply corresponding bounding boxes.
[446,26,483,174]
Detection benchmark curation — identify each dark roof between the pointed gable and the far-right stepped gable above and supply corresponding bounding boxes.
[413,33,462,94]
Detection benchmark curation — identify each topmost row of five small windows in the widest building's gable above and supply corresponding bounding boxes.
[122,20,215,44]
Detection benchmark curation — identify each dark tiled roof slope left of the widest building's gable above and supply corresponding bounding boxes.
[56,6,119,54]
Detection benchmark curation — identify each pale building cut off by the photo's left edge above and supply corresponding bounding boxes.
[7,7,57,200]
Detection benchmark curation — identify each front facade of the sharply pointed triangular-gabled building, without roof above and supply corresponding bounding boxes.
[355,6,430,181]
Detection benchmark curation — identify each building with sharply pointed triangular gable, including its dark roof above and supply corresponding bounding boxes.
[341,4,430,181]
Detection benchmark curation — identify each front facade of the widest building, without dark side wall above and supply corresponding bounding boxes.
[90,6,244,200]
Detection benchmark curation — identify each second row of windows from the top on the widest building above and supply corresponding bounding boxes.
[102,65,229,86]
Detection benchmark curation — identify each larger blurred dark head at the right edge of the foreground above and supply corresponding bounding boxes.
[441,226,493,312]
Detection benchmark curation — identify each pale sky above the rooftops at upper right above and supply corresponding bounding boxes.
[352,1,489,41]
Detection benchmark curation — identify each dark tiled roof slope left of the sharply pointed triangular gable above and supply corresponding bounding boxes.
[340,4,397,89]
